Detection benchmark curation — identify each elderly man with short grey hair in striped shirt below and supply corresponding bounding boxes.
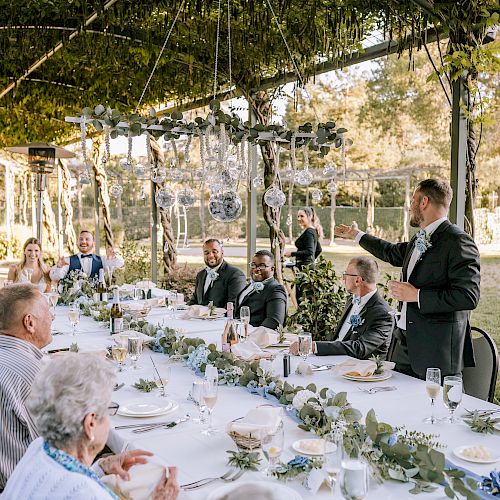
[0,285,53,491]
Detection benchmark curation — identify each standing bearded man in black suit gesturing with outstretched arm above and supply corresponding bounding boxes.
[335,179,480,379]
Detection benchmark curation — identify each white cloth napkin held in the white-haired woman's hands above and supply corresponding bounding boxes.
[101,462,166,500]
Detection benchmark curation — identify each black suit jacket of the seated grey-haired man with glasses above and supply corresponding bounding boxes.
[316,292,394,359]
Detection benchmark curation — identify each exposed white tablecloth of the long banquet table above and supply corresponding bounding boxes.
[46,306,500,500]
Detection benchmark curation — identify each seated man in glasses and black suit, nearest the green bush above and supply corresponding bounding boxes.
[235,250,287,330]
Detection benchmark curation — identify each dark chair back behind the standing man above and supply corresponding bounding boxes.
[462,326,498,402]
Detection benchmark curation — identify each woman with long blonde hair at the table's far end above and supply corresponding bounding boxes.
[7,238,51,293]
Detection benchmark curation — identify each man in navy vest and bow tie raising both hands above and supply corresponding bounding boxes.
[50,231,124,281]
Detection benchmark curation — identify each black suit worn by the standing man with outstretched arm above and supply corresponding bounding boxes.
[359,221,480,377]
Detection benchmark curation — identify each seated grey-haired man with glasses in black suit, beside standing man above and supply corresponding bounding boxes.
[290,256,394,359]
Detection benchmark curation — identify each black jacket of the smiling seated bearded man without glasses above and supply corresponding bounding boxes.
[188,261,247,307]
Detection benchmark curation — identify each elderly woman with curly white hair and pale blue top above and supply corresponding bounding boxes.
[2,353,179,500]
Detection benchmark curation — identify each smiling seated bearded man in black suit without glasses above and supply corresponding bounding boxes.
[188,238,246,307]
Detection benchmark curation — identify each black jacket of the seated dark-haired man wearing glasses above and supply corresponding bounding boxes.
[236,278,287,330]
